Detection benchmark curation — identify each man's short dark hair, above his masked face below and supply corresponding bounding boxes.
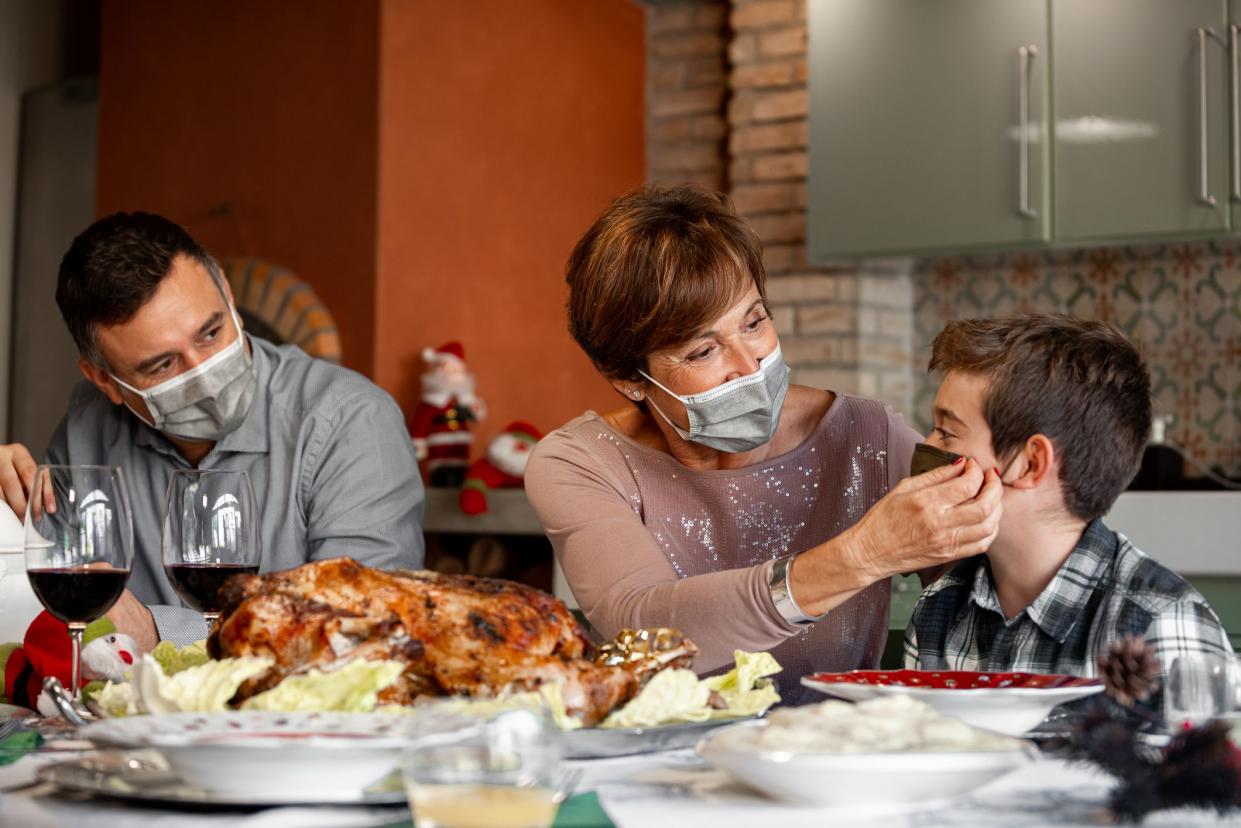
[56,212,223,367]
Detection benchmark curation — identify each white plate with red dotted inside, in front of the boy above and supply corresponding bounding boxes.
[802,670,1103,736]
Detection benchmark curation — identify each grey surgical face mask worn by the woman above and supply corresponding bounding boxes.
[639,344,788,453]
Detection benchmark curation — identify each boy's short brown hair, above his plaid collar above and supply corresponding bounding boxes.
[928,314,1150,520]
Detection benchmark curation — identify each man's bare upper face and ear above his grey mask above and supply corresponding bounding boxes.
[82,256,240,422]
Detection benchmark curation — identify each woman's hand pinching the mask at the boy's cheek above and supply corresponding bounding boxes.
[840,458,1003,582]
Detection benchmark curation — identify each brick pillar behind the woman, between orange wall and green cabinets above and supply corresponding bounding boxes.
[647,0,913,412]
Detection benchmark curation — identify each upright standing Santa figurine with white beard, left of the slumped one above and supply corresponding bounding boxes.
[410,343,486,487]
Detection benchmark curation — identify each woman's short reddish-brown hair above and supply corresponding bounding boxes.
[566,185,767,380]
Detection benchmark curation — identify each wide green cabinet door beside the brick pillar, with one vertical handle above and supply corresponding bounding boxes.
[808,0,1050,258]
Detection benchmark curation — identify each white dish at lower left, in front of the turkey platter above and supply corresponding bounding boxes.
[78,711,410,802]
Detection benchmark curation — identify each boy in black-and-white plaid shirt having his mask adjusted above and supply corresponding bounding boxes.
[905,315,1232,675]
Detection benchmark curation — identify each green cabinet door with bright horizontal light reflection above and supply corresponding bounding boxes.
[1051,0,1232,243]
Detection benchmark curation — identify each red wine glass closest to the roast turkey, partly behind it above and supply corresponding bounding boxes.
[161,469,261,624]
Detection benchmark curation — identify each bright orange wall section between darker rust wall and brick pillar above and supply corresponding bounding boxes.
[375,0,645,452]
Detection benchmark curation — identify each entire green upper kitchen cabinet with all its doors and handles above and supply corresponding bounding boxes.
[807,0,1241,261]
